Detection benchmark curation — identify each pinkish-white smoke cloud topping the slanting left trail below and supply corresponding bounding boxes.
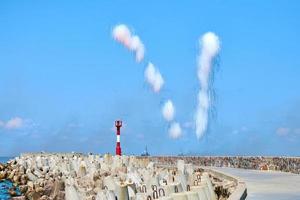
[112,24,145,62]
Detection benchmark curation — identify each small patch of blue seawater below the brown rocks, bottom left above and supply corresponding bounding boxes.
[0,180,21,200]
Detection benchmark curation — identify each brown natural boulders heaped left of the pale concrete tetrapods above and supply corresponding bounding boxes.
[0,157,64,200]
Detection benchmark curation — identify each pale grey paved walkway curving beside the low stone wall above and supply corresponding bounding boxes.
[212,168,300,200]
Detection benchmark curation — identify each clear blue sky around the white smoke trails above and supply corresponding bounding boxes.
[0,0,300,156]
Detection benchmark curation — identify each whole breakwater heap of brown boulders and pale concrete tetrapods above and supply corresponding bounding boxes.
[0,154,236,200]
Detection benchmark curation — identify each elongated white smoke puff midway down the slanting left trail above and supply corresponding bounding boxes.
[145,62,164,92]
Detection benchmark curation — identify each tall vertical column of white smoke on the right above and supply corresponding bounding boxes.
[195,32,220,139]
